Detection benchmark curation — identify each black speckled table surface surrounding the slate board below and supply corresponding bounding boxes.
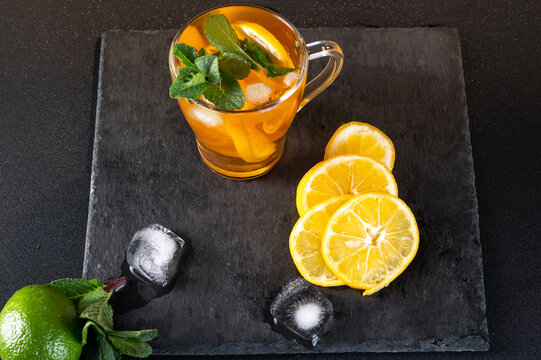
[0,0,541,360]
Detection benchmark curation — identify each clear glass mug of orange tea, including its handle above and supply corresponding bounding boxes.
[169,5,344,180]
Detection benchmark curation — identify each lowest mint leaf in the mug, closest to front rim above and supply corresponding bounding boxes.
[204,70,244,110]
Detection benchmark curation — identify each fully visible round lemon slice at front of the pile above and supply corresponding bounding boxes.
[321,193,419,295]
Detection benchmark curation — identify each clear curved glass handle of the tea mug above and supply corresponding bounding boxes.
[297,40,344,112]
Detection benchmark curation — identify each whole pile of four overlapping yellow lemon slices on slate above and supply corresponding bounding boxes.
[289,122,419,295]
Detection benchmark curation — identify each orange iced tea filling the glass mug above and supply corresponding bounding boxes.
[170,6,306,179]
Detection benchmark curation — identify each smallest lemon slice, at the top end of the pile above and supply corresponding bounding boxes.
[325,121,395,170]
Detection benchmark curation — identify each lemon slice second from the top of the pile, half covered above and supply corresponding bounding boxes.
[297,155,398,216]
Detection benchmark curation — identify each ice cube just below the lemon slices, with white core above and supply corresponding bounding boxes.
[270,278,333,346]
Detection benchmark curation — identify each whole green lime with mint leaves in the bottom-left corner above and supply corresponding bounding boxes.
[0,277,158,360]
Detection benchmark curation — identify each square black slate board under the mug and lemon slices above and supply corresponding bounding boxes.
[83,28,489,354]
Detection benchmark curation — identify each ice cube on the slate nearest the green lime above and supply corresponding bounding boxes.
[126,224,186,288]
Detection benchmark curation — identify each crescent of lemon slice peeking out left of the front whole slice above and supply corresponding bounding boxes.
[289,195,353,287]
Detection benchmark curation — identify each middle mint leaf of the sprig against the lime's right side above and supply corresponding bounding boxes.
[78,287,113,330]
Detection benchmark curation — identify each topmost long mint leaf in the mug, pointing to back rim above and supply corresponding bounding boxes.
[205,14,259,68]
